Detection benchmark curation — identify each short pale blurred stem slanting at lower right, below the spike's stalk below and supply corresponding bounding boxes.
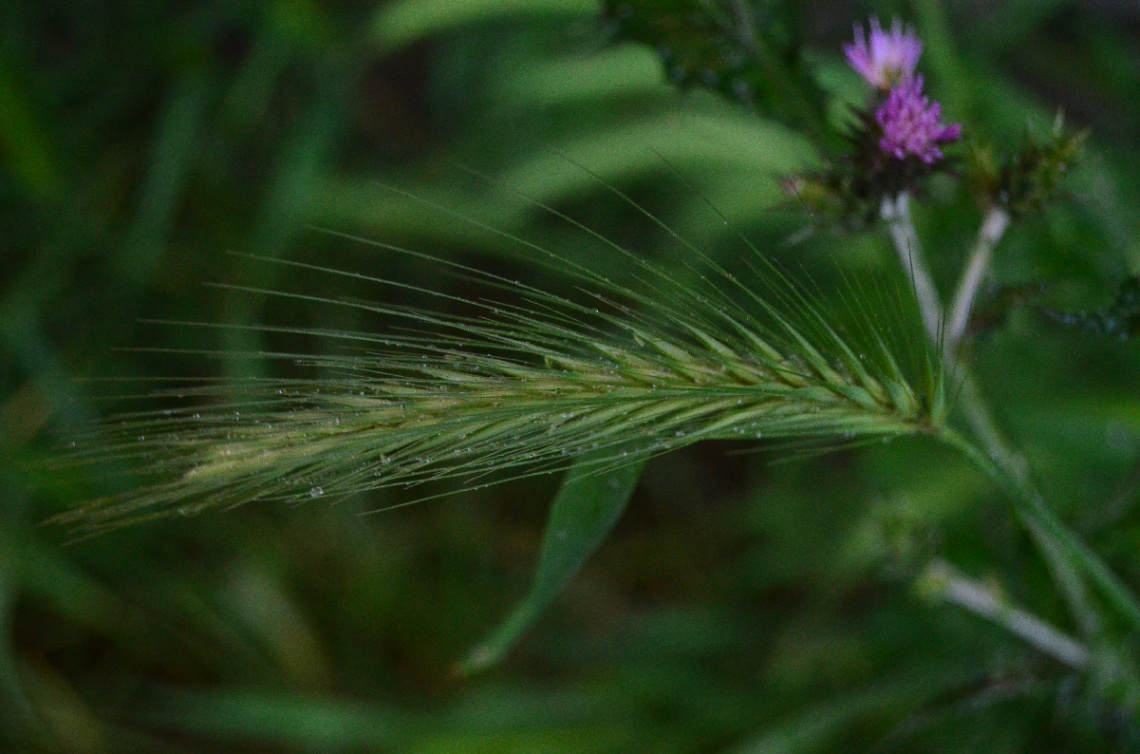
[919,560,1092,671]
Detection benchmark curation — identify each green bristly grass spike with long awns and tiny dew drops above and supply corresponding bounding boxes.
[58,197,945,532]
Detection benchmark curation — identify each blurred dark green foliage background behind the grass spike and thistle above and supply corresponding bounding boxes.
[0,0,1140,754]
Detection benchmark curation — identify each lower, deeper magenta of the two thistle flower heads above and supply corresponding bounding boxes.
[874,76,962,165]
